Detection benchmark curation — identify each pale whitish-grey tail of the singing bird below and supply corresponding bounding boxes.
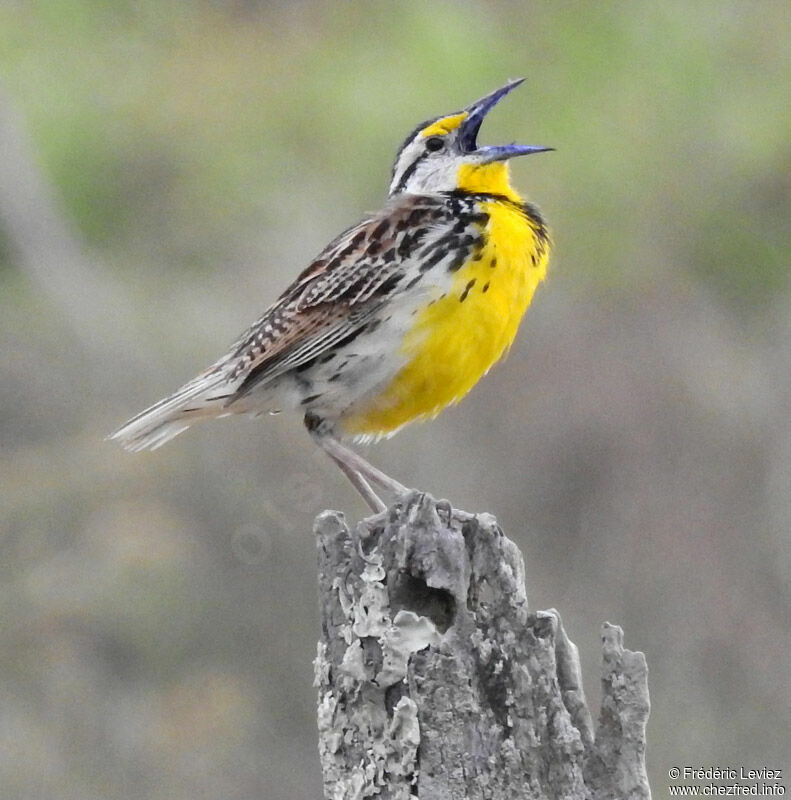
[107,371,228,452]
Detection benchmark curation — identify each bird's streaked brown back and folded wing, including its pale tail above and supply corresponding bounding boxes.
[111,195,475,450]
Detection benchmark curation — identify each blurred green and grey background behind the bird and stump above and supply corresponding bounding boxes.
[0,0,791,800]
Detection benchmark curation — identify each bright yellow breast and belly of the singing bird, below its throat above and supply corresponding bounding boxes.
[342,190,548,436]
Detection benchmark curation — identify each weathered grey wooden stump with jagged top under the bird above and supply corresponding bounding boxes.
[315,492,650,800]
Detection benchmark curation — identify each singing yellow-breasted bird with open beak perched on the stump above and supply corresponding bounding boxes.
[108,78,554,512]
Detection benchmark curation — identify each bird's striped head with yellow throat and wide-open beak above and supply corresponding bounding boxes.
[389,79,552,197]
